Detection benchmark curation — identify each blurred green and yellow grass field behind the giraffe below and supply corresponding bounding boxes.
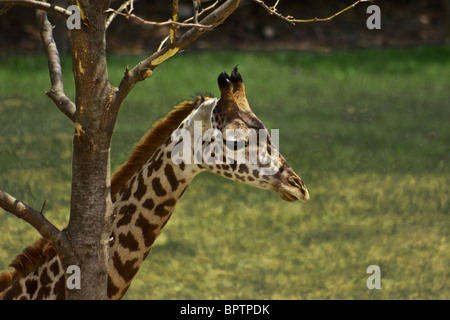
[0,46,450,299]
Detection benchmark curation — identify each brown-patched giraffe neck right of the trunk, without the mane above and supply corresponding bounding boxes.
[108,137,200,299]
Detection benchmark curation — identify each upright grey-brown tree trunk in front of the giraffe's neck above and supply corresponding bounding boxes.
[65,1,116,299]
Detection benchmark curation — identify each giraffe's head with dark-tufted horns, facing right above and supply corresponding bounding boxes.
[172,68,309,201]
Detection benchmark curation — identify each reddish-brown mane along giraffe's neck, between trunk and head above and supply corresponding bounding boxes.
[111,96,208,196]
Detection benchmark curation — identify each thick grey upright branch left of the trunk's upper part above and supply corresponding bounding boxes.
[37,10,76,122]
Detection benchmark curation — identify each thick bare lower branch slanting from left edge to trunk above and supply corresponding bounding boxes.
[0,189,63,243]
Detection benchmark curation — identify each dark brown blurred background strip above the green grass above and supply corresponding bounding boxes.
[0,0,450,54]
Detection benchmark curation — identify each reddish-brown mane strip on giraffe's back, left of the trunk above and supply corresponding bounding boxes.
[0,238,56,293]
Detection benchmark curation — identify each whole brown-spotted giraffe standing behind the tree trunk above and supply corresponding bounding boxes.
[0,67,309,299]
